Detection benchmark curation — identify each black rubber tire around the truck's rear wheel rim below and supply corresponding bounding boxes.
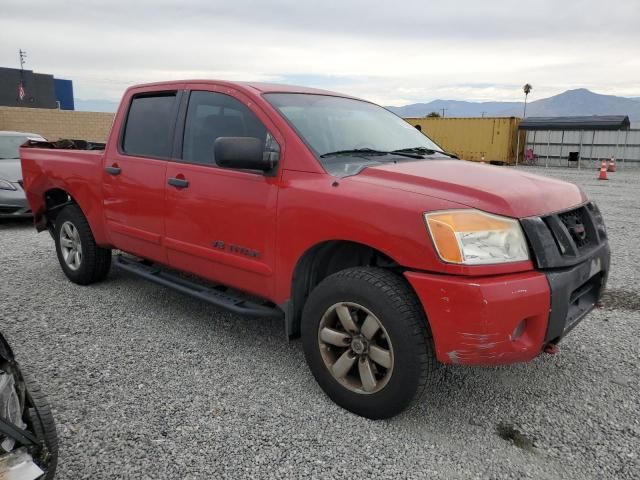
[54,205,111,285]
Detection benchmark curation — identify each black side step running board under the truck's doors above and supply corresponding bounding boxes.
[115,255,284,319]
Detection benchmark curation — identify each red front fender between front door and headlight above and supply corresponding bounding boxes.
[276,171,459,302]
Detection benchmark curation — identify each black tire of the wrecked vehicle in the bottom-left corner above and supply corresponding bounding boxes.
[22,371,58,480]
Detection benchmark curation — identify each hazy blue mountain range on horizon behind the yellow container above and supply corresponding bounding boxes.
[387,88,640,121]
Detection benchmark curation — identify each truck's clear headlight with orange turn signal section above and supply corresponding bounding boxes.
[424,210,529,265]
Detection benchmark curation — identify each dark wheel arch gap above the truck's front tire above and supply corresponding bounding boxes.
[285,240,403,338]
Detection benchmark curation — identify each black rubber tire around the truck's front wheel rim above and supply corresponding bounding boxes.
[302,267,436,419]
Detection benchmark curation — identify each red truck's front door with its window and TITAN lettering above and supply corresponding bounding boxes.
[165,86,279,297]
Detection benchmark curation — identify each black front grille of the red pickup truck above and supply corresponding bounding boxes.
[521,203,607,268]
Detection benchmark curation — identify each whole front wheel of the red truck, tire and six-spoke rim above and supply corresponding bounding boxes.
[302,267,435,419]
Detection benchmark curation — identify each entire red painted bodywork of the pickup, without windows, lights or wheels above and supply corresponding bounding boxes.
[21,80,586,364]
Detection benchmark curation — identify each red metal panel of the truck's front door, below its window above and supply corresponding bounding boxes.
[164,162,278,298]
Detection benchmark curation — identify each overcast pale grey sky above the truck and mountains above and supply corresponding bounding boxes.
[0,0,640,105]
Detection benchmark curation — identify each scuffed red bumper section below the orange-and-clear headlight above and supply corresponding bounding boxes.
[405,272,550,365]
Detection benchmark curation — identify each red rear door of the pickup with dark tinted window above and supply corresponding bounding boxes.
[103,90,181,263]
